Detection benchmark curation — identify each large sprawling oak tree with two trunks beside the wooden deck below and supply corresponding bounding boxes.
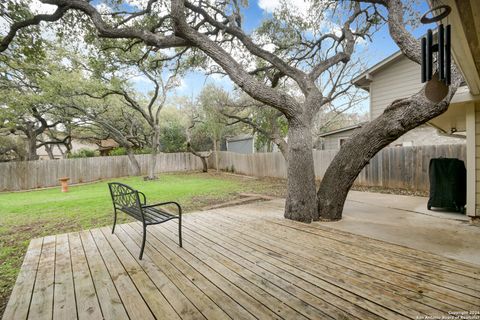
[0,0,460,222]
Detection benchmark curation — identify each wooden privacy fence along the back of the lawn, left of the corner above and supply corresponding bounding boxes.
[0,153,202,191]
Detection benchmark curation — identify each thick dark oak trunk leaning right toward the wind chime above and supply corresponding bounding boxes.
[315,80,461,221]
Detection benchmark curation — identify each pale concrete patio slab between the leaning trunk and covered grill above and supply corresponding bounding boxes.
[338,191,480,265]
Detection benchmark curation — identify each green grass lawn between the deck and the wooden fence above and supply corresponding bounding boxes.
[0,173,285,317]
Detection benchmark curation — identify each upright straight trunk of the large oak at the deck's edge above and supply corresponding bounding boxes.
[285,120,317,223]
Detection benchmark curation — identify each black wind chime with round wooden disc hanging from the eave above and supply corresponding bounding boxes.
[420,5,452,103]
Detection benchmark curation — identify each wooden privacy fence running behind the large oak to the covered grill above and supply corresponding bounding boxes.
[210,144,466,191]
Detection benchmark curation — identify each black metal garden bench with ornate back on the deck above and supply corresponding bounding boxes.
[108,182,182,260]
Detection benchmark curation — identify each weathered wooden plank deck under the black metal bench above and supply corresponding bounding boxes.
[4,202,480,320]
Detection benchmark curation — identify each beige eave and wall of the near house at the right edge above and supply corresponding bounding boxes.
[432,0,480,222]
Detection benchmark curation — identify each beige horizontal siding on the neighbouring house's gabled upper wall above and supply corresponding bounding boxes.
[370,56,422,120]
